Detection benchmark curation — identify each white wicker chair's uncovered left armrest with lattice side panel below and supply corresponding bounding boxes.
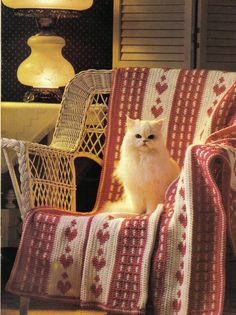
[1,138,76,217]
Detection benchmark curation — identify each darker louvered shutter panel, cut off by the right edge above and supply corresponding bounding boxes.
[197,0,236,71]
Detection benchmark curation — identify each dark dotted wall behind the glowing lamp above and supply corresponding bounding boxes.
[1,0,113,101]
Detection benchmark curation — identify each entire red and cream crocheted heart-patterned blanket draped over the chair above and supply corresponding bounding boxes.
[7,68,236,315]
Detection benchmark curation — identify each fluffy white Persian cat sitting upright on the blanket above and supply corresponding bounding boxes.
[102,117,180,214]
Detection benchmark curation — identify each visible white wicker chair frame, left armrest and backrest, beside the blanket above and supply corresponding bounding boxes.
[2,70,111,218]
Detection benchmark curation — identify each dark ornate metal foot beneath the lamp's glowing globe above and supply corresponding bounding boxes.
[23,88,63,103]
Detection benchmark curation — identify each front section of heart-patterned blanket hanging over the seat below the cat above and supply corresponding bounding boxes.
[8,208,161,314]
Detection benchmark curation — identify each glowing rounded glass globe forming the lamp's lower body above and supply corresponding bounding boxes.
[17,35,75,88]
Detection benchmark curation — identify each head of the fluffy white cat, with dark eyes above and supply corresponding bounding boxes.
[124,117,163,151]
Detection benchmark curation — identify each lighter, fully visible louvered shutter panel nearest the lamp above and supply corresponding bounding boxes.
[113,0,193,68]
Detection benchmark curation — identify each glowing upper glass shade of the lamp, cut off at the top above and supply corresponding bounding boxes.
[2,0,93,10]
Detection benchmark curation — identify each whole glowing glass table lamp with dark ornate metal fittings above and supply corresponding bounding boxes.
[2,0,93,101]
